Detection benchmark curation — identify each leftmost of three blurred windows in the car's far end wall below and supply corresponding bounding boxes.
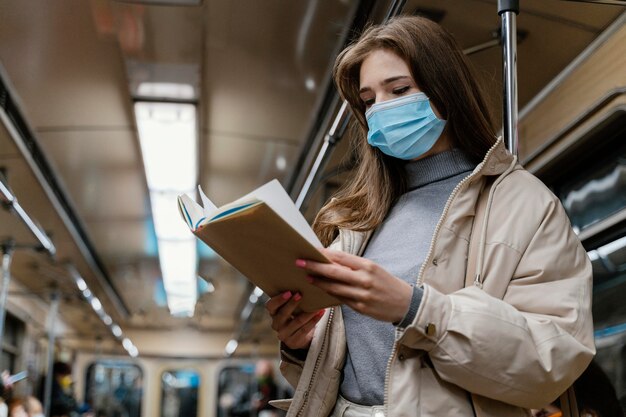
[85,360,143,417]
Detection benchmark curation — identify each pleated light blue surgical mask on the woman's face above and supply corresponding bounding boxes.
[365,93,446,160]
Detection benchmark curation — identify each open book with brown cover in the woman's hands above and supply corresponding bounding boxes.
[178,180,340,312]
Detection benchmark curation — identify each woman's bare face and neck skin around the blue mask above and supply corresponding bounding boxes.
[359,49,450,159]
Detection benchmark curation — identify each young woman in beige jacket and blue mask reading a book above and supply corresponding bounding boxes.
[266,17,594,417]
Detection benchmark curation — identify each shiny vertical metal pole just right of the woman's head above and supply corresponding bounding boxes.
[498,0,519,155]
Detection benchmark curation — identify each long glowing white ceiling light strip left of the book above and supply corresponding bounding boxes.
[135,101,198,317]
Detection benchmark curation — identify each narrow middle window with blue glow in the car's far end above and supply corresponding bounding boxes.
[161,369,200,417]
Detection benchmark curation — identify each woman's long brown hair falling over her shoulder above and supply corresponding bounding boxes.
[313,16,496,246]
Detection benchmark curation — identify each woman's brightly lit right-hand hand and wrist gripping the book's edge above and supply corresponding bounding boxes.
[296,249,413,323]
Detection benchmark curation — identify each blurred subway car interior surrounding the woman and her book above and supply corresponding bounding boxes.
[0,0,626,417]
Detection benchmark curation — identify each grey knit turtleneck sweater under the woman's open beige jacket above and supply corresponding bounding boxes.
[341,149,475,406]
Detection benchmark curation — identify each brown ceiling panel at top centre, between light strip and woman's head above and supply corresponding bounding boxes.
[205,0,354,148]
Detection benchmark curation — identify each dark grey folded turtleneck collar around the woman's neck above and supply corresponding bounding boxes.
[405,148,476,191]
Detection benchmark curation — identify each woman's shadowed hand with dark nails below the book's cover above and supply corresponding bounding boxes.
[265,291,324,349]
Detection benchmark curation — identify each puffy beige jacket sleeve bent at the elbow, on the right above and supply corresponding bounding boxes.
[398,174,595,408]
